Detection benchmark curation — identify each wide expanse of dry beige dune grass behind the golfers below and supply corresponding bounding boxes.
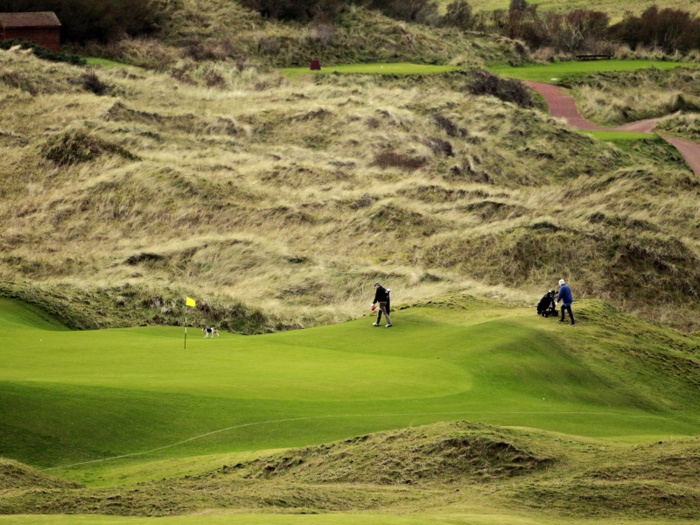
[0,47,700,329]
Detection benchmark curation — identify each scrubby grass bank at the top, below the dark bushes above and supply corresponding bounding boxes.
[78,0,527,70]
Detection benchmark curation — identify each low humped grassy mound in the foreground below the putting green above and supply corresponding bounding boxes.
[223,423,553,485]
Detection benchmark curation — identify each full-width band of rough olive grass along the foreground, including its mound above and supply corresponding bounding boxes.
[0,422,700,520]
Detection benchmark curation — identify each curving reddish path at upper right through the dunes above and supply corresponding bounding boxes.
[524,81,700,177]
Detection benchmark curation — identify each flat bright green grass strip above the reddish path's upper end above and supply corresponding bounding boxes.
[489,60,688,83]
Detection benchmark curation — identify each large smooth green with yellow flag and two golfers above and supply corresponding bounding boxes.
[0,299,700,484]
